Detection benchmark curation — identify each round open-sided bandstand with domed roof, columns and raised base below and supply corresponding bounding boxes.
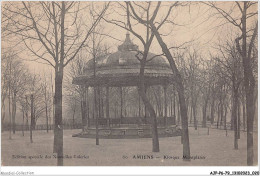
[73,33,180,138]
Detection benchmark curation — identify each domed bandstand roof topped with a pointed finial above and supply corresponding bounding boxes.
[73,33,172,87]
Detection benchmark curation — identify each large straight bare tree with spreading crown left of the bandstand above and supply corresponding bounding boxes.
[3,1,108,165]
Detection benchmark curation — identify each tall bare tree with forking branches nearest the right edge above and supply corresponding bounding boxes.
[204,1,258,166]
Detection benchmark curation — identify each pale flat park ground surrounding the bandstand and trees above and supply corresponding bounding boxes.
[1,128,258,166]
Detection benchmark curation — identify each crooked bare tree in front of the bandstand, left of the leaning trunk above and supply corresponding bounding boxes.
[105,2,159,152]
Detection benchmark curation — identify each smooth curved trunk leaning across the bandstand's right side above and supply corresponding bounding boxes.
[150,24,190,161]
